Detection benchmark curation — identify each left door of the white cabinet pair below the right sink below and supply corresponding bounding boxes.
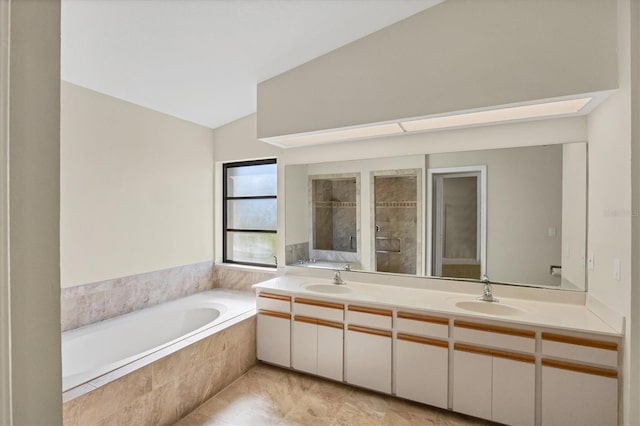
[452,350,493,419]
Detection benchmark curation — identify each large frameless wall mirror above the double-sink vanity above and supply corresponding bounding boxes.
[285,143,587,291]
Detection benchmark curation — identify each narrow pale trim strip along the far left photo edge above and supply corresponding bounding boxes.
[0,0,13,425]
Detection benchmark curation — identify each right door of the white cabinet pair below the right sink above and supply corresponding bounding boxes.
[491,356,536,425]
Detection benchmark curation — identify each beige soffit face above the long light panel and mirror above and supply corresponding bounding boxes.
[258,0,617,137]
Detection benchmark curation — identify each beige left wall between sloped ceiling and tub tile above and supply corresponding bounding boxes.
[60,82,213,287]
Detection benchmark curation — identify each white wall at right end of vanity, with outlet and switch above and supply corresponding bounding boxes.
[587,0,640,424]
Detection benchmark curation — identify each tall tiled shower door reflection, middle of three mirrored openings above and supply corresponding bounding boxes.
[374,176,418,274]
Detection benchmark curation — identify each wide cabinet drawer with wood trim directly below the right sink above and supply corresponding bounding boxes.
[453,320,536,352]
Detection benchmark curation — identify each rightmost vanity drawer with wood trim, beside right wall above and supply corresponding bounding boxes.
[542,333,618,367]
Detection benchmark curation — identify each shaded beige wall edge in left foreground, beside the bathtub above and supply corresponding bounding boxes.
[7,0,62,425]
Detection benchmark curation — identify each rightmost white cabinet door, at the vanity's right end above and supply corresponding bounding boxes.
[542,360,618,426]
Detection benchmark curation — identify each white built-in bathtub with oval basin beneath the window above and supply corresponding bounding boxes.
[62,289,256,392]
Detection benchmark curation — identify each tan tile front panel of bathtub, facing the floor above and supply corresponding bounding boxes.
[63,316,256,425]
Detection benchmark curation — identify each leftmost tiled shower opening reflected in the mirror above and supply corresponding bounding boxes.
[312,178,357,252]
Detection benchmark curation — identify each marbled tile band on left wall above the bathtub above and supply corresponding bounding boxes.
[60,261,218,331]
